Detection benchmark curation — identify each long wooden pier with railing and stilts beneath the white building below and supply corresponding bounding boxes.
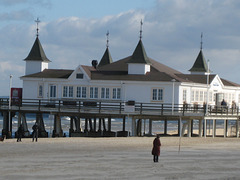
[0,98,240,138]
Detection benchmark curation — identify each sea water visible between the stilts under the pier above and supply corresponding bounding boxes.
[0,113,236,137]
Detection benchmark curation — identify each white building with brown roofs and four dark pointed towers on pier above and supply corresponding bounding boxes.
[21,26,240,105]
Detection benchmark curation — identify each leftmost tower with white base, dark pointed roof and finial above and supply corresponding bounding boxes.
[24,19,51,75]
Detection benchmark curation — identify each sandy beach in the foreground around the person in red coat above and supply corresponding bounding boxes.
[0,137,240,180]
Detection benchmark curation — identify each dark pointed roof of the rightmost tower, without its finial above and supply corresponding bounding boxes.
[189,50,208,72]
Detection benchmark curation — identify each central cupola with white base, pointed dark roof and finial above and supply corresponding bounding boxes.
[127,21,151,75]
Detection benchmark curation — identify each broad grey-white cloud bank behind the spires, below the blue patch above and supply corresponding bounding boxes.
[0,0,240,95]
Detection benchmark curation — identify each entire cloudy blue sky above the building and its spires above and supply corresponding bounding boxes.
[0,0,240,95]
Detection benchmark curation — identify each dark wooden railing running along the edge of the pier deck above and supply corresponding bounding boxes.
[0,98,239,116]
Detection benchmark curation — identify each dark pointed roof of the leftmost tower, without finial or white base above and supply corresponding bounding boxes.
[24,37,51,62]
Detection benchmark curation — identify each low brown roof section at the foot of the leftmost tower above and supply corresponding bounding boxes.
[22,69,74,79]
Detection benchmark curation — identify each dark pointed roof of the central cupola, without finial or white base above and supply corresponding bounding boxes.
[128,39,151,64]
